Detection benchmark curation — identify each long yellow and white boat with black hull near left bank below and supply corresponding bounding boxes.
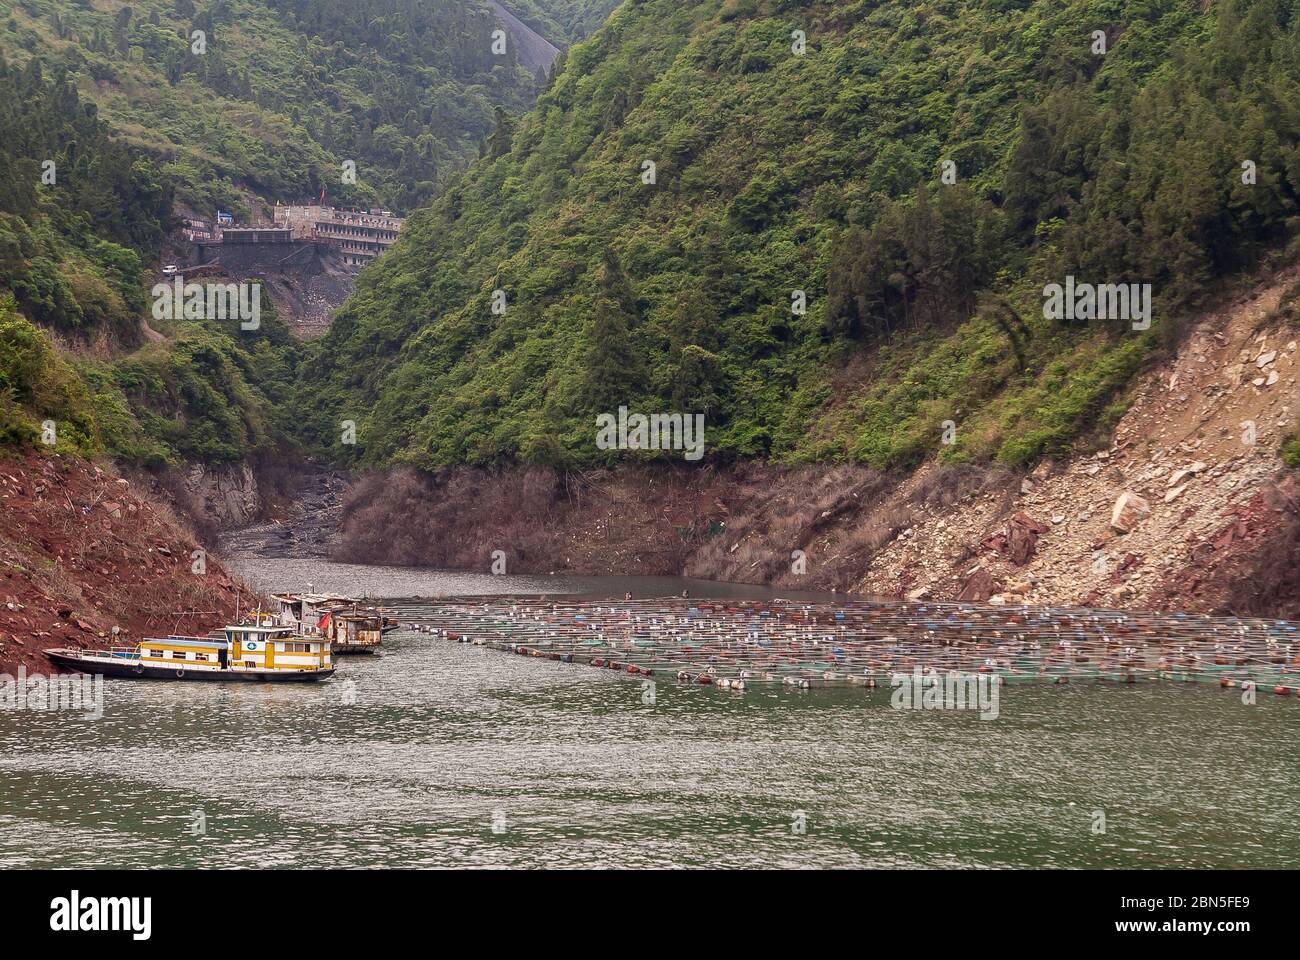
[46,623,334,682]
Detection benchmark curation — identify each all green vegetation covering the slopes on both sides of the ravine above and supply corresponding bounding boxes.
[10,0,1300,481]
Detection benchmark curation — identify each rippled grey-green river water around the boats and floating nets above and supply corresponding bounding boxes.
[0,559,1300,868]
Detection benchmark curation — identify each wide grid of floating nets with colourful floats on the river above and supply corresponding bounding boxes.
[400,597,1300,696]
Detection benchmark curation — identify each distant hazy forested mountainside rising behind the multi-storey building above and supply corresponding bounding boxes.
[0,0,574,216]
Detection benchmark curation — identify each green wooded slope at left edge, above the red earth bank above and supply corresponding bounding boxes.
[0,44,302,464]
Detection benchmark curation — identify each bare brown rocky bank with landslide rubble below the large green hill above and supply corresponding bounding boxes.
[327,267,1300,618]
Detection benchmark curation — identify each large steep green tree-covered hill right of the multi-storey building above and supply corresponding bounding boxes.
[303,0,1300,466]
